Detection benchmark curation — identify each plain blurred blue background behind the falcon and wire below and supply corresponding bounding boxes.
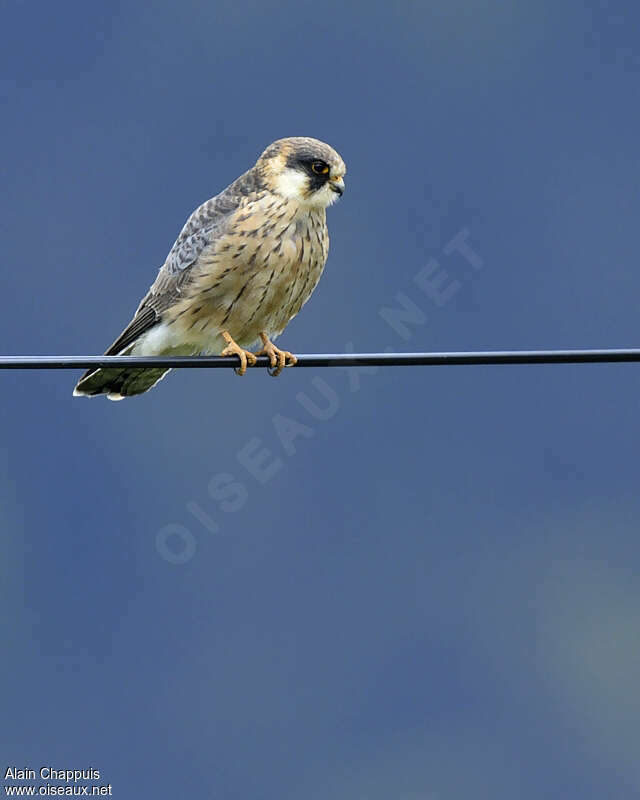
[0,0,640,800]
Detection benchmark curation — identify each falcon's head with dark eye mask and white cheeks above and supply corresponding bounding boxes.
[256,136,347,208]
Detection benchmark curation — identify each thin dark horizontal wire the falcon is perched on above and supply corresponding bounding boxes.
[0,348,640,369]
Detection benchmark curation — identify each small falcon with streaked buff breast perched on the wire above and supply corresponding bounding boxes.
[73,136,346,400]
